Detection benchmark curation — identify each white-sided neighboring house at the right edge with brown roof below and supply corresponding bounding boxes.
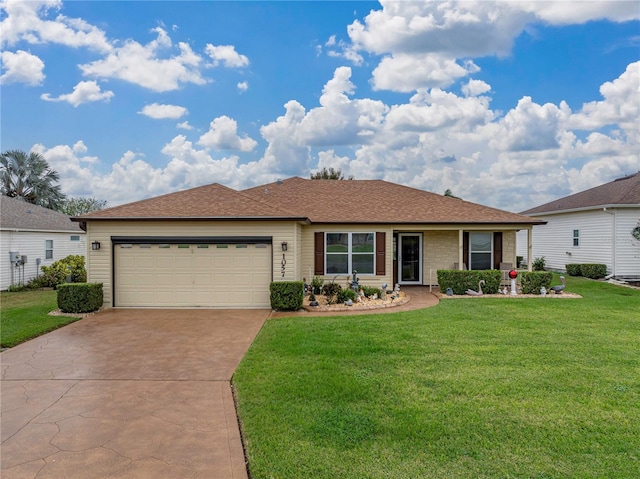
[518,173,640,279]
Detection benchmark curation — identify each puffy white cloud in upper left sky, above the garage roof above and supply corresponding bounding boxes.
[80,27,207,92]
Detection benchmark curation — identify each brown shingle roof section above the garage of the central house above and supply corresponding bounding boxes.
[74,183,302,221]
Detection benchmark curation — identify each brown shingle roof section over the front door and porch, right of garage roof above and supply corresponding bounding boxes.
[244,177,538,224]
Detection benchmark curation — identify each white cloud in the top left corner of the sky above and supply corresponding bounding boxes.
[0,0,112,52]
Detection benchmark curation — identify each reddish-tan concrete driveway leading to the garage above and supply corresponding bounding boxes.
[0,309,269,479]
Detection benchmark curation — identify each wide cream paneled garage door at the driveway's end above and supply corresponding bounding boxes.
[114,244,272,308]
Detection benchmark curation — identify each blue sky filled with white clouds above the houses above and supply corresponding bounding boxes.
[0,0,640,212]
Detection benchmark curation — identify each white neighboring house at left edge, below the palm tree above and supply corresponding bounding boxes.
[0,196,87,291]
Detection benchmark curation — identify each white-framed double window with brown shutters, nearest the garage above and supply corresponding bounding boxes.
[325,233,375,275]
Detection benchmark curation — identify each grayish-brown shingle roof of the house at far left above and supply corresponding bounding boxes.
[0,195,84,233]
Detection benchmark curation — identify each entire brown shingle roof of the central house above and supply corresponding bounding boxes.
[77,177,541,224]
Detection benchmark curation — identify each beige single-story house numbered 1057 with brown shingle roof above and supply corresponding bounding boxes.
[74,177,542,307]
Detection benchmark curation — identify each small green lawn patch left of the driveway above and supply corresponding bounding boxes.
[0,290,77,348]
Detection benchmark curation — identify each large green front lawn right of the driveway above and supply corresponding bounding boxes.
[233,277,640,479]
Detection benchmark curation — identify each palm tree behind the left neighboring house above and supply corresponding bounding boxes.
[0,150,66,209]
